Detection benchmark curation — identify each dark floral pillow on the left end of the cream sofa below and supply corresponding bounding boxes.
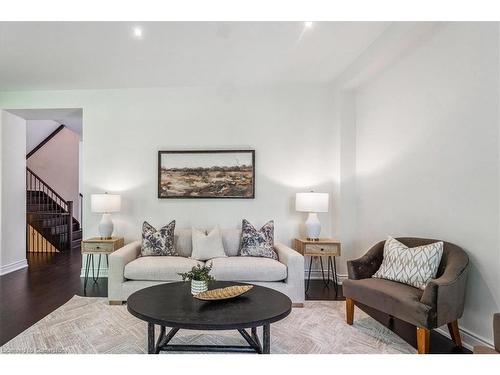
[141,220,179,256]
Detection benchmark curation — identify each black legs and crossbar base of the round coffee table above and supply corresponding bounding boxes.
[148,323,271,354]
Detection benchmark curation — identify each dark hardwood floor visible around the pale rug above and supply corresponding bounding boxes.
[0,250,470,354]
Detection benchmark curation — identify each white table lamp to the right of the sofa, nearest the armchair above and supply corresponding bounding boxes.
[295,192,328,241]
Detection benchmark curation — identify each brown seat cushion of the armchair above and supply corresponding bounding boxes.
[342,278,432,327]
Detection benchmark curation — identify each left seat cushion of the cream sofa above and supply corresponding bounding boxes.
[124,256,204,281]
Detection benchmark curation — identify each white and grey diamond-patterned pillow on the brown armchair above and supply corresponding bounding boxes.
[372,237,443,289]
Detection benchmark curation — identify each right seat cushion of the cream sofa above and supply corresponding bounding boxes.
[207,256,287,281]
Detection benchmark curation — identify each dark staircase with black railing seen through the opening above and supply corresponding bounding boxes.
[26,168,74,252]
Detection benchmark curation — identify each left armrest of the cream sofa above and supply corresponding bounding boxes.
[108,240,141,300]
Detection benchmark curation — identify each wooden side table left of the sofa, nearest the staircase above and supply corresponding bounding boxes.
[82,237,124,294]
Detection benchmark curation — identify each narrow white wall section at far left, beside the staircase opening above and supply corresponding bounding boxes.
[0,110,27,275]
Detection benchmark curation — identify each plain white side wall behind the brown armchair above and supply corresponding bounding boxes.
[355,23,500,342]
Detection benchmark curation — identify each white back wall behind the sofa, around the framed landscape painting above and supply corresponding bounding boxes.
[0,85,337,276]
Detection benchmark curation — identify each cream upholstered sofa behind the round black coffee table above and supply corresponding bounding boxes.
[108,229,305,307]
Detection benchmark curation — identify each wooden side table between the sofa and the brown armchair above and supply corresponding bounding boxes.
[293,238,340,296]
